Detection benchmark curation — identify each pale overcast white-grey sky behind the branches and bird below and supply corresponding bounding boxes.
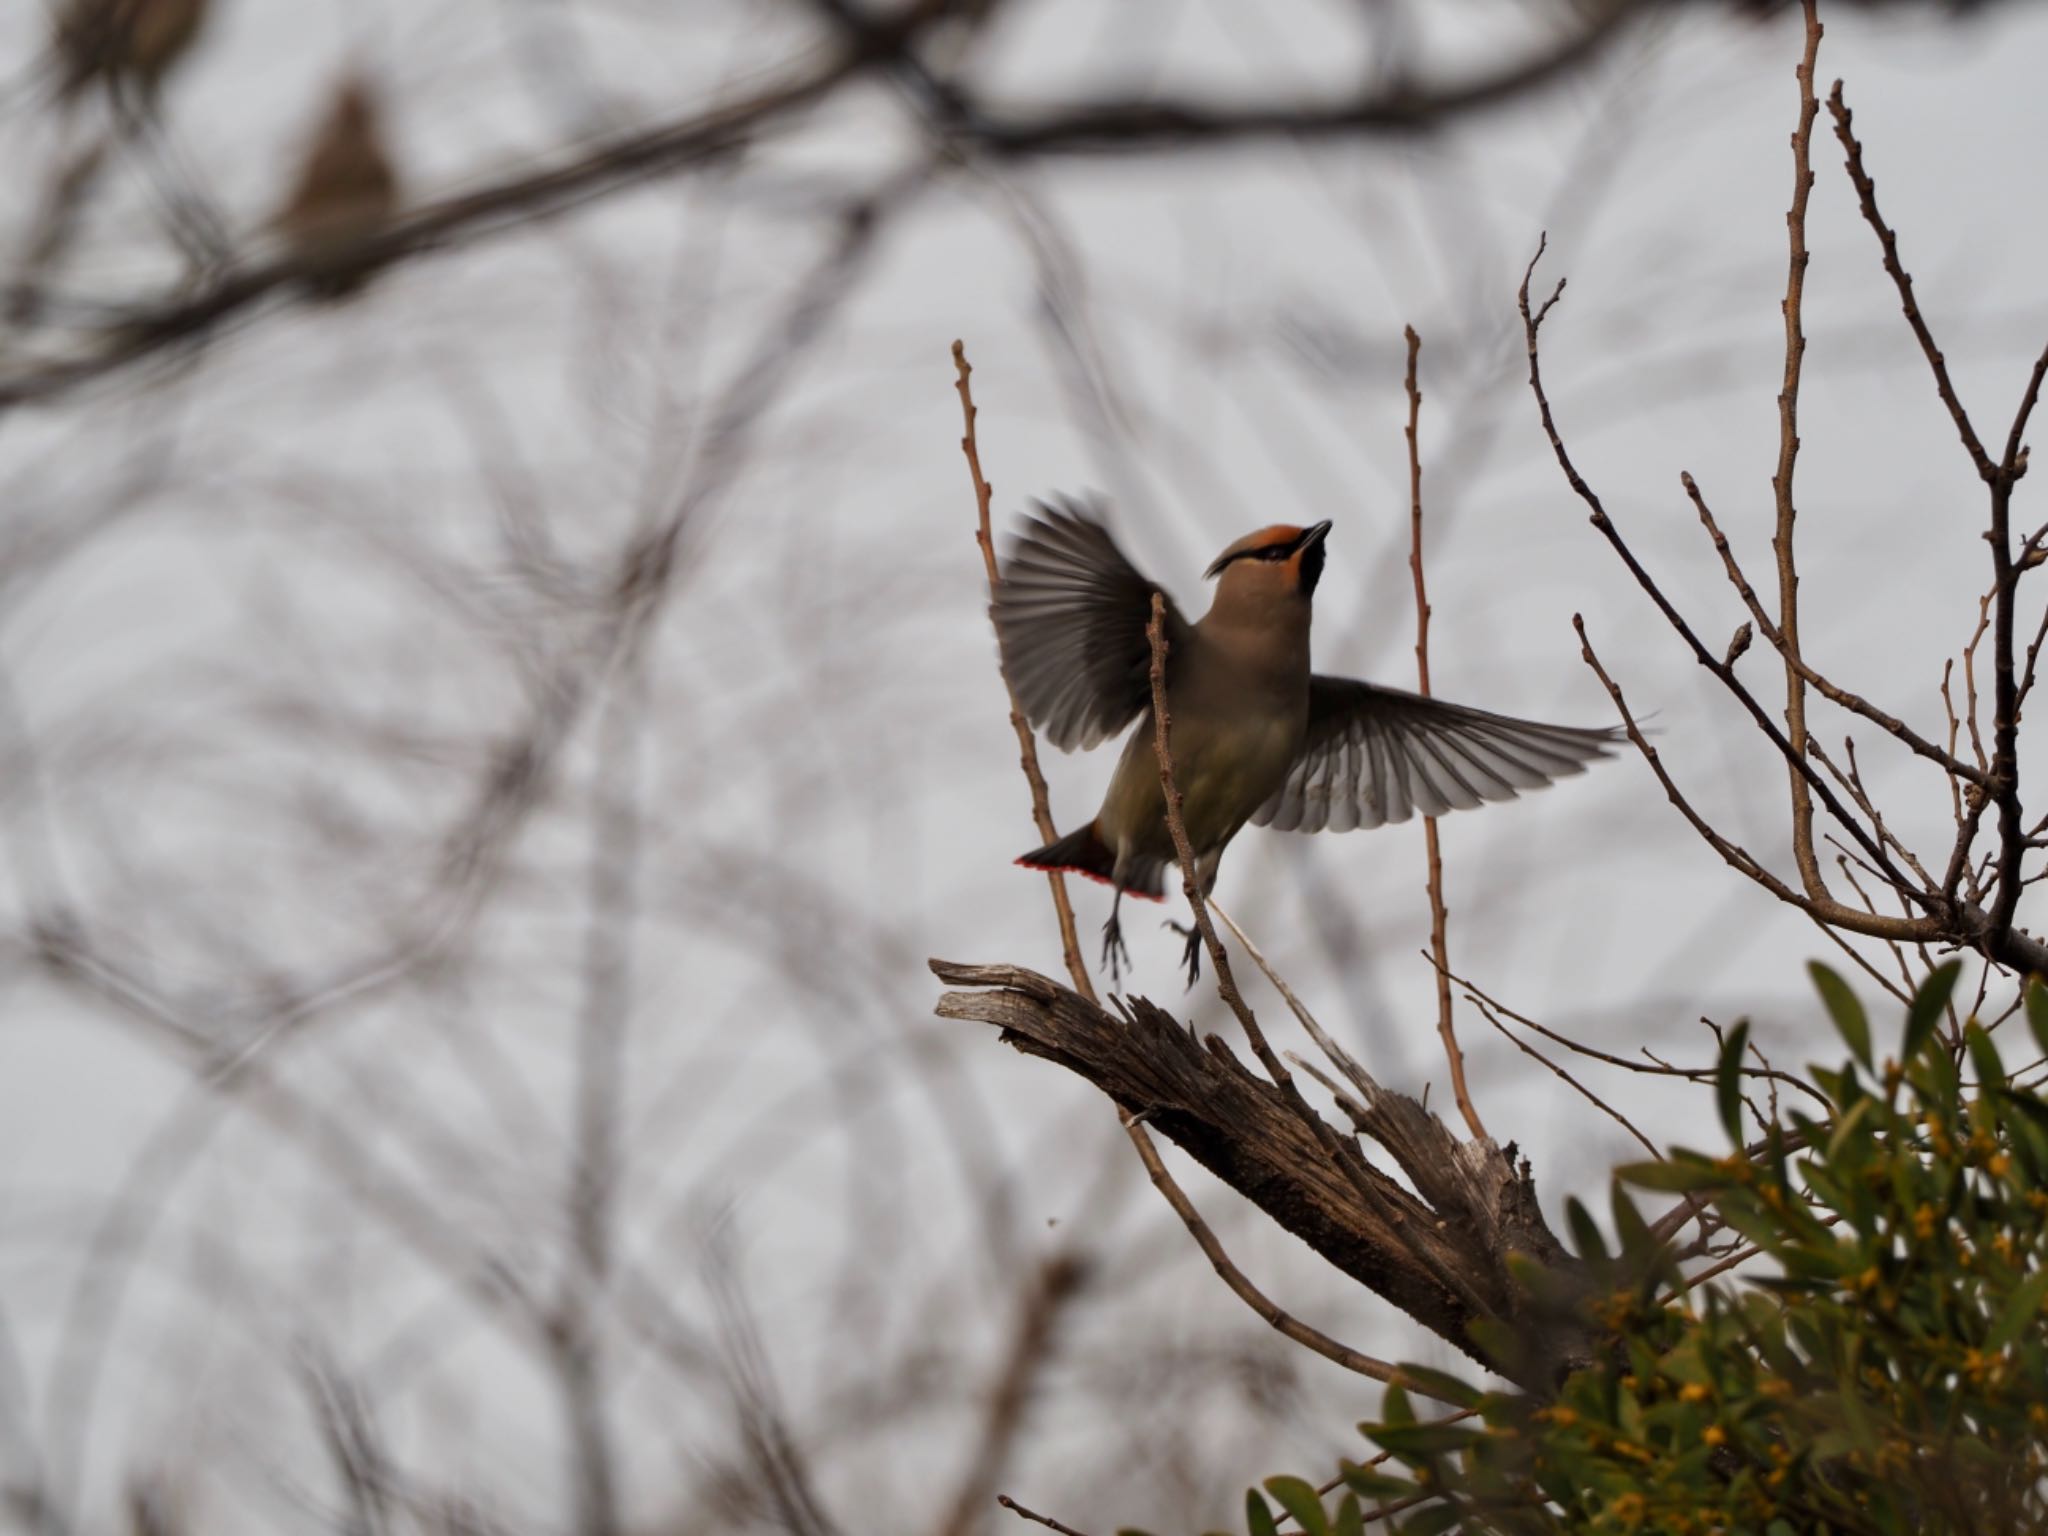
[0,0,2048,1530]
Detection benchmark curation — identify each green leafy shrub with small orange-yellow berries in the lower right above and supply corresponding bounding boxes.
[1196,961,2048,1536]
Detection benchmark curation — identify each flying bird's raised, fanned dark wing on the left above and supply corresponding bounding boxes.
[989,502,1190,752]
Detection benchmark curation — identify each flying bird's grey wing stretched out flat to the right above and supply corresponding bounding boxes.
[1251,676,1622,831]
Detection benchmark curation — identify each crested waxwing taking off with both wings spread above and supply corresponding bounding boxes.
[989,498,1622,987]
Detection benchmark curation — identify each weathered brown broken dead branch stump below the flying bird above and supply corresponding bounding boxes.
[932,961,1591,1391]
